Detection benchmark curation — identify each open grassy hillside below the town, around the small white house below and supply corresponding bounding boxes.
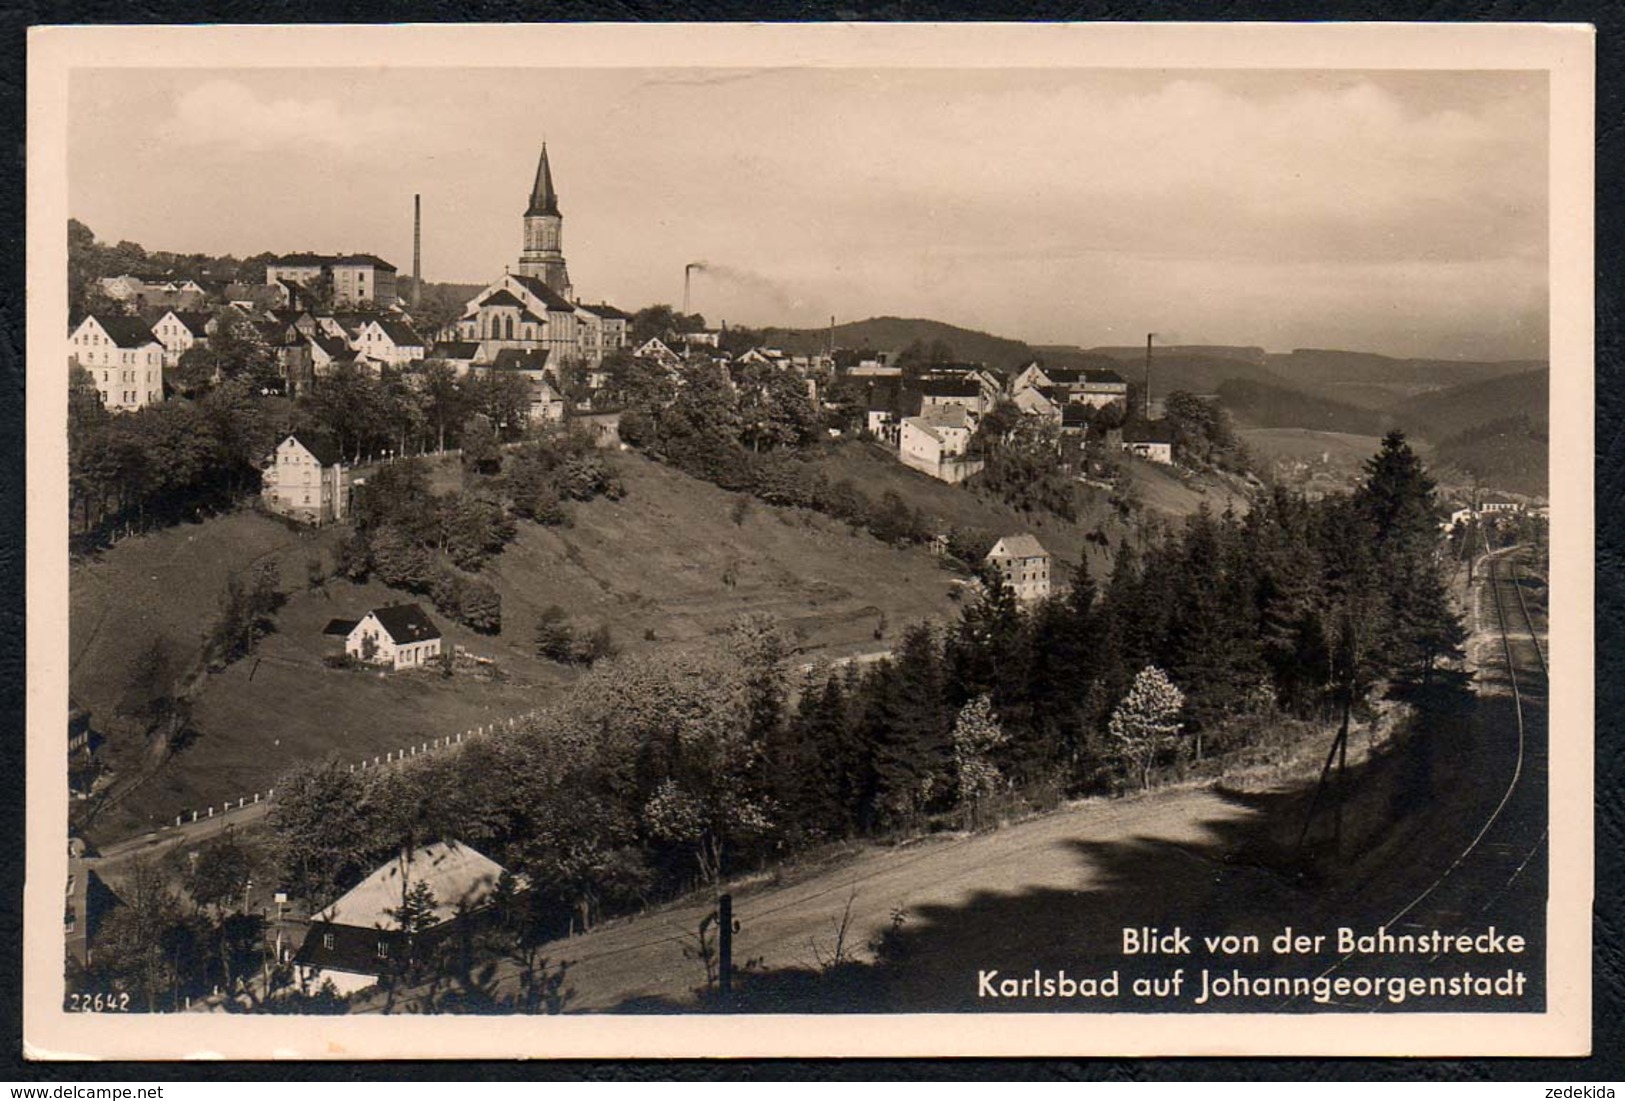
[82,447,1116,840]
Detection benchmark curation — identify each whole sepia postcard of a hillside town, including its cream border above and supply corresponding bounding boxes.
[24,24,1593,1059]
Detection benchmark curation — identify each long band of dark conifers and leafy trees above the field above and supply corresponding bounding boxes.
[273,437,1461,948]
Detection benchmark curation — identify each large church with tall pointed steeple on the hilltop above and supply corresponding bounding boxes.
[442,143,632,369]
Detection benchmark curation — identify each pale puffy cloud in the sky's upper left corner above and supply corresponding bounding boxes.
[163,80,408,154]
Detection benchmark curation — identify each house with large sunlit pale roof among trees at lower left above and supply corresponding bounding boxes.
[294,841,510,994]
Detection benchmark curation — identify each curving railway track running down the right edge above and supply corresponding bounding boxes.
[1300,547,1549,1012]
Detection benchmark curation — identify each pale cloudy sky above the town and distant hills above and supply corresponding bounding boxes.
[68,68,1549,359]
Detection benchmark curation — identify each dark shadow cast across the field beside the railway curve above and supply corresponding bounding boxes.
[613,677,1544,1013]
